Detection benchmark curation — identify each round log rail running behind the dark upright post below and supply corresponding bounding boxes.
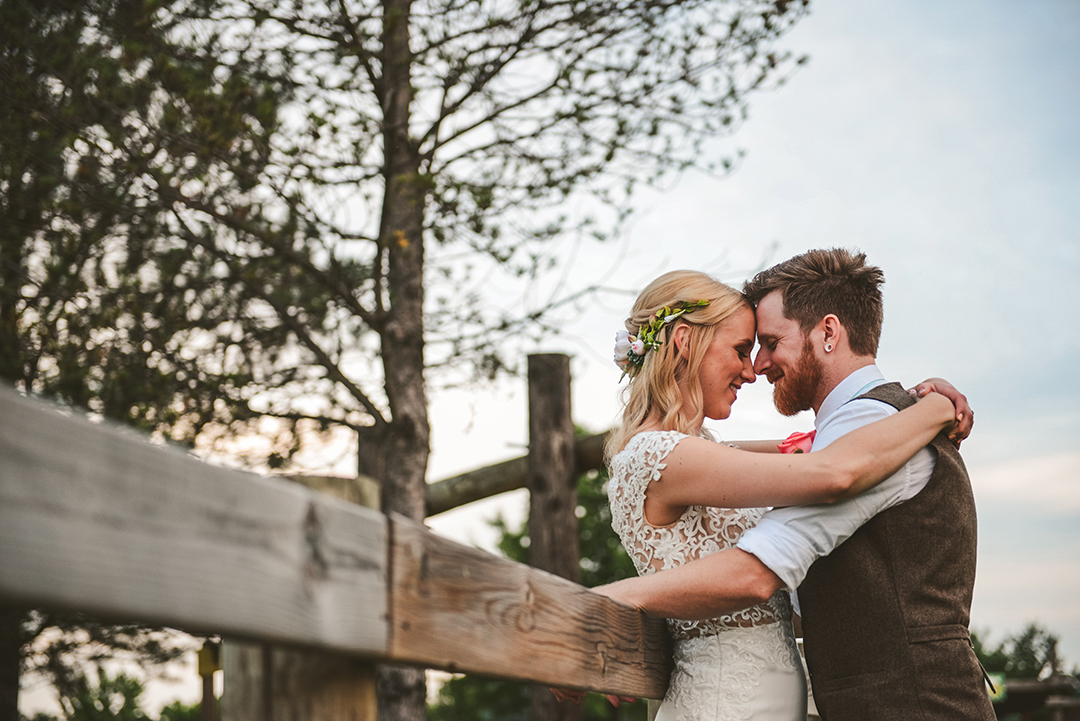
[424,433,607,516]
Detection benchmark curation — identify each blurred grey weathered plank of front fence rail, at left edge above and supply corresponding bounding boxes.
[0,389,387,655]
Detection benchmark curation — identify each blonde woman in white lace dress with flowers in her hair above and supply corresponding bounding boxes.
[587,271,956,721]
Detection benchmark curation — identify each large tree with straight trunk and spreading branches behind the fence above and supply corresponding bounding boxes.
[0,0,809,718]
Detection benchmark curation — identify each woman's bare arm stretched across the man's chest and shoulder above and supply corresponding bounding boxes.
[646,393,955,509]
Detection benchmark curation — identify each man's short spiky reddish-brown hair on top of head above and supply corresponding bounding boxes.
[743,248,885,356]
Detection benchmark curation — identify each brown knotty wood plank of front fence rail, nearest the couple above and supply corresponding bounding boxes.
[390,515,671,698]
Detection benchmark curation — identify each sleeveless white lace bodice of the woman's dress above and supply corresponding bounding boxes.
[608,431,792,639]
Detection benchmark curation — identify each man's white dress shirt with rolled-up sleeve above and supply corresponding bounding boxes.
[737,365,936,600]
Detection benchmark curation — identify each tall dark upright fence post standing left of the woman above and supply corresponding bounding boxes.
[527,353,582,721]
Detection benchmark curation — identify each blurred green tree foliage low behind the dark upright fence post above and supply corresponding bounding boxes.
[428,471,646,721]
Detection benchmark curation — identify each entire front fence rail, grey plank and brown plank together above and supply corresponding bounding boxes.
[0,389,671,698]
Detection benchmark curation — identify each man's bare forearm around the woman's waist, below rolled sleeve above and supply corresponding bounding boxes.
[593,548,784,621]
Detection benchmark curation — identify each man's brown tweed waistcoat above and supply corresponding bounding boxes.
[799,383,995,721]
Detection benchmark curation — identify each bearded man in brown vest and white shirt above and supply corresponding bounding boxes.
[599,249,995,721]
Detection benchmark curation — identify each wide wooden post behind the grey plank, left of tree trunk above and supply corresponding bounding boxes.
[221,476,379,721]
